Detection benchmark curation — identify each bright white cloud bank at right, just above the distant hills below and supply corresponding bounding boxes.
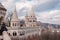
[37,10,60,24]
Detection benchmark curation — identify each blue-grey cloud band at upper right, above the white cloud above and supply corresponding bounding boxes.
[35,0,60,12]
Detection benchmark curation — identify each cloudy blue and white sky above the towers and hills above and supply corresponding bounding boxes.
[0,0,60,24]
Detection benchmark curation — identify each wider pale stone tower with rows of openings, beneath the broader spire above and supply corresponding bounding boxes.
[25,7,37,27]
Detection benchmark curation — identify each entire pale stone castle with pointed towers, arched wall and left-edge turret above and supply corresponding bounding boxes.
[0,3,40,40]
